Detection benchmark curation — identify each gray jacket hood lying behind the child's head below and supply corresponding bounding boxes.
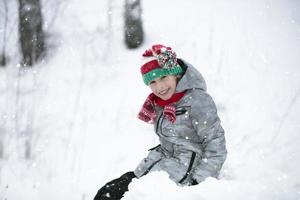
[176,59,206,93]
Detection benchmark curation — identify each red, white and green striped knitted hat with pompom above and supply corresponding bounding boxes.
[141,44,182,85]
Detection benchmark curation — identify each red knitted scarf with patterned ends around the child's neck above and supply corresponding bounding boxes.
[138,92,185,124]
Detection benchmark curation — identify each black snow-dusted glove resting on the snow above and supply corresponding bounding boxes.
[94,172,136,200]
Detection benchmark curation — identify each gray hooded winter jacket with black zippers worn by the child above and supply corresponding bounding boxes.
[134,59,227,185]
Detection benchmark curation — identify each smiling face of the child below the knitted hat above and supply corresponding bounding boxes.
[149,75,177,100]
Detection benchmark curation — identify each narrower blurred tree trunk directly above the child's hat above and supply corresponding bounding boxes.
[125,0,144,49]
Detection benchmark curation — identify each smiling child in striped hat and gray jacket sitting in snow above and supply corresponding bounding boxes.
[95,45,227,200]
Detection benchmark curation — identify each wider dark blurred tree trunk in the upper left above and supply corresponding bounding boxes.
[19,0,45,66]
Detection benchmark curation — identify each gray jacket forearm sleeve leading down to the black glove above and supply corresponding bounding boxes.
[134,145,163,178]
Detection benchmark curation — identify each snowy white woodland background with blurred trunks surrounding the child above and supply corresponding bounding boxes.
[0,0,300,200]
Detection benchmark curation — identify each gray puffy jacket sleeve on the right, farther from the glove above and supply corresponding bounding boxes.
[190,91,227,183]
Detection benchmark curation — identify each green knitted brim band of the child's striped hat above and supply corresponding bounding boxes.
[143,65,182,85]
